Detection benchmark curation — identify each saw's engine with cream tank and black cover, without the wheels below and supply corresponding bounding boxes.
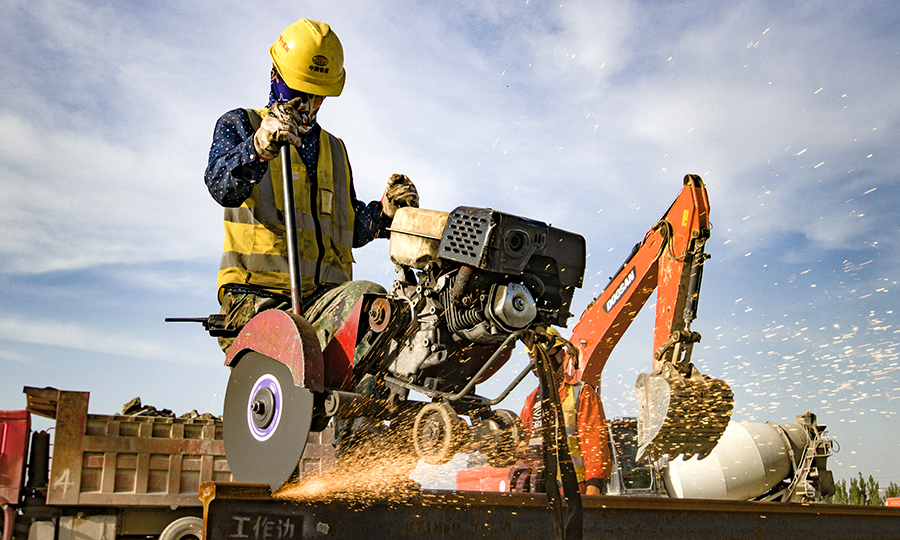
[364,207,585,397]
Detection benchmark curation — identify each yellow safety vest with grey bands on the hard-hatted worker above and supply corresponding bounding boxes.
[217,109,355,301]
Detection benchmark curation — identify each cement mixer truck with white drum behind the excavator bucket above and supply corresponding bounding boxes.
[456,413,834,502]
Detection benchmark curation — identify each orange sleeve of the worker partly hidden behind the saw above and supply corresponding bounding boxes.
[578,383,610,495]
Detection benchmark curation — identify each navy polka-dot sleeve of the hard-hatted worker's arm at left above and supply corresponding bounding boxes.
[204,109,268,208]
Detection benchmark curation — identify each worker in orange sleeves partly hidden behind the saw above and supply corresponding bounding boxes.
[520,328,610,495]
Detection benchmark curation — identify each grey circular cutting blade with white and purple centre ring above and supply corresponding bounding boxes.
[223,351,313,492]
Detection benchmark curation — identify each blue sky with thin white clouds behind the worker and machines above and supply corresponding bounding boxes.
[0,0,900,484]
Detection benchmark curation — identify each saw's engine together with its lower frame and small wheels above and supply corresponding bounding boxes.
[342,207,585,466]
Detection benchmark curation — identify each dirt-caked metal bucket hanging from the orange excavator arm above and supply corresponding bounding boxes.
[635,362,734,459]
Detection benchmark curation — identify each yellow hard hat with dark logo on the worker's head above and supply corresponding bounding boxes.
[269,19,346,96]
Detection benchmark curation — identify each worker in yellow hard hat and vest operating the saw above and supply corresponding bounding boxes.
[205,19,419,354]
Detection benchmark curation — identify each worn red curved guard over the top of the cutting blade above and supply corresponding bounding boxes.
[225,309,325,392]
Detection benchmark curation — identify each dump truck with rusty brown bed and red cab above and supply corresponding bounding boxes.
[0,387,333,540]
